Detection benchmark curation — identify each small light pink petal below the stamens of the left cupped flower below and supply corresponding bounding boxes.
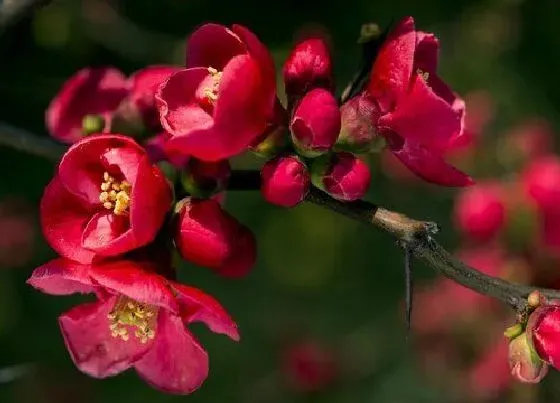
[82,211,132,256]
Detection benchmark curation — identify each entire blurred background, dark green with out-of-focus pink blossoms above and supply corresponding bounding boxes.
[0,0,560,403]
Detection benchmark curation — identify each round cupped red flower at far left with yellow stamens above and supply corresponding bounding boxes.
[41,135,171,263]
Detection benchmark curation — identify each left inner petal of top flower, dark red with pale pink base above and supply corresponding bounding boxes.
[156,68,213,136]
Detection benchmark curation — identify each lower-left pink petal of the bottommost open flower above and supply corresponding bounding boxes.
[58,297,152,378]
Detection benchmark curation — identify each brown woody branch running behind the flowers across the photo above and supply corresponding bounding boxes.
[0,122,560,313]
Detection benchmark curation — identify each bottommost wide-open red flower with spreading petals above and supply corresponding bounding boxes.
[28,258,239,394]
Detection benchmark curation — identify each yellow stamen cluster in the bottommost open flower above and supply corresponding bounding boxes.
[107,295,157,344]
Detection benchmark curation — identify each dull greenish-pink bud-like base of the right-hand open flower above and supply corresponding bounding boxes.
[336,92,385,153]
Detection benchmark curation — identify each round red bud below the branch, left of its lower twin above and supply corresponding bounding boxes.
[261,155,311,207]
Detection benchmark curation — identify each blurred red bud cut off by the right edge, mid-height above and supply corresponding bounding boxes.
[522,155,560,213]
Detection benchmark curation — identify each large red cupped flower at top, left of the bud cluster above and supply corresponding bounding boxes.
[156,24,276,161]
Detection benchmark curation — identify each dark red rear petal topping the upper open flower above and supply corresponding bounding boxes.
[186,24,247,70]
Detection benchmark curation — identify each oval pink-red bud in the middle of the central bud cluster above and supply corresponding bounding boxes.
[290,88,340,158]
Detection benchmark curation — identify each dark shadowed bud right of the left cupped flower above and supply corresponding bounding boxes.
[181,158,231,198]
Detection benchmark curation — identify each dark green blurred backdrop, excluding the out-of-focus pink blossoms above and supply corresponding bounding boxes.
[0,0,560,403]
